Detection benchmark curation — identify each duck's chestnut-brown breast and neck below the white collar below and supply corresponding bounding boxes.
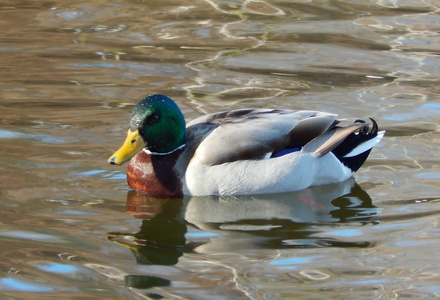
[127,145,185,196]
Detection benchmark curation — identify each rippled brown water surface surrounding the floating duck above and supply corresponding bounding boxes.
[0,0,440,299]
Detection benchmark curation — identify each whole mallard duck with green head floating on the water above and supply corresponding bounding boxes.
[108,95,385,196]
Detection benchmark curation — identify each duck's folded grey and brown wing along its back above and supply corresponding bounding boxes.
[187,109,337,165]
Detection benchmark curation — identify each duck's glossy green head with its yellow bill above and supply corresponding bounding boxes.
[108,95,185,165]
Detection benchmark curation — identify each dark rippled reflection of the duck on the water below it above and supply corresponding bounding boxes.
[108,179,377,265]
